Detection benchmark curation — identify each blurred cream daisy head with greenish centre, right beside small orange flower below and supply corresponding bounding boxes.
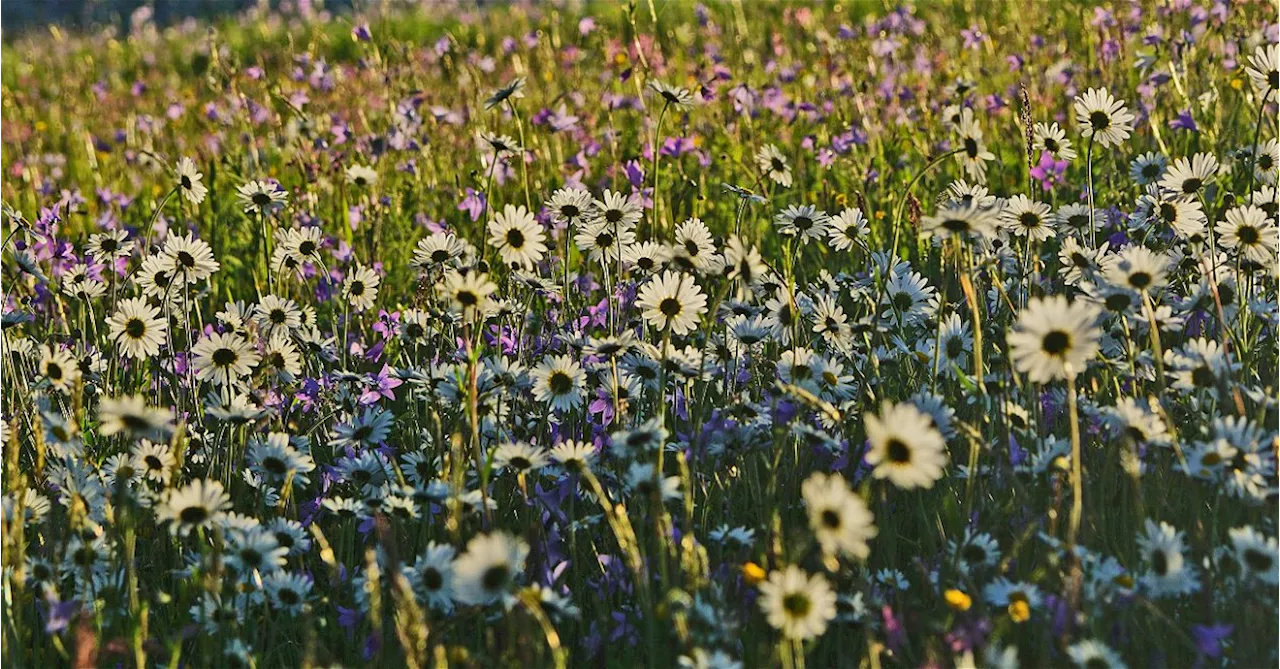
[759,564,836,641]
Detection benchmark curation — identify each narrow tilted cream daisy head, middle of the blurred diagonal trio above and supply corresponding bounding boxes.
[800,472,877,559]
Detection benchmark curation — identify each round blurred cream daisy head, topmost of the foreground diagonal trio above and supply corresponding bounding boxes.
[863,402,947,490]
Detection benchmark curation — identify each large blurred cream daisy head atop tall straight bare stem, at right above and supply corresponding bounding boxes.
[1009,295,1102,384]
